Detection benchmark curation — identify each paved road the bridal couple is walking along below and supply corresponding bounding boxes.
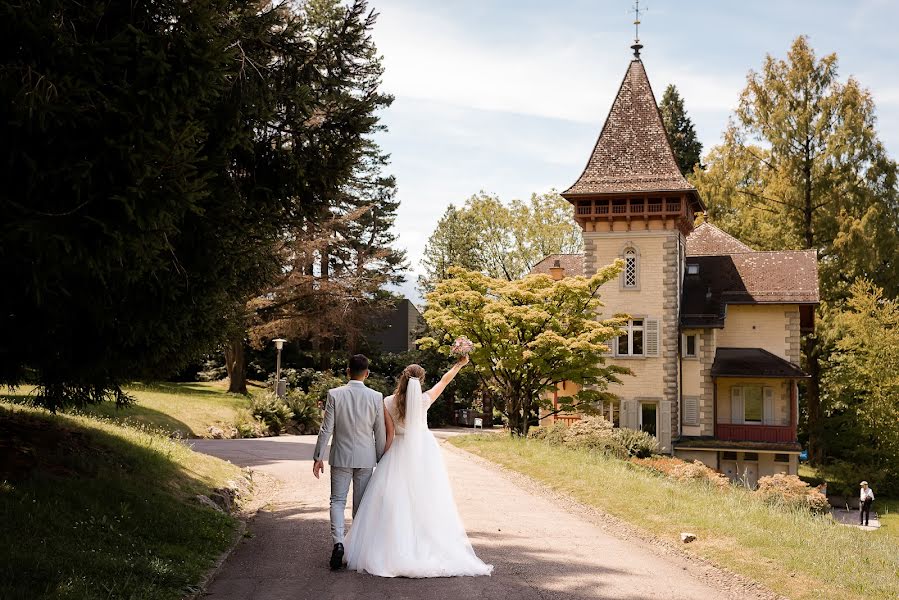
[193,436,752,600]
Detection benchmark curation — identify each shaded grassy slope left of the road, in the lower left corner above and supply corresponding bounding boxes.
[0,402,241,600]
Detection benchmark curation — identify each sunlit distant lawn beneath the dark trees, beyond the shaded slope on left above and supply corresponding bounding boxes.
[7,381,261,437]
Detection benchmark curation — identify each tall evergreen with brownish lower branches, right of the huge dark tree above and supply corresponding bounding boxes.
[241,0,405,378]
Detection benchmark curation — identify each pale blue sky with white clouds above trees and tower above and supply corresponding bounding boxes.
[370,0,899,302]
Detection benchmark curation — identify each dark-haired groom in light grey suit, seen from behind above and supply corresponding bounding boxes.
[312,354,387,571]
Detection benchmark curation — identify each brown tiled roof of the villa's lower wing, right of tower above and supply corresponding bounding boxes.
[681,250,819,327]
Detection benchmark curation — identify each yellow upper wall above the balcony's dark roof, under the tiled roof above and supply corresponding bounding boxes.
[717,304,799,360]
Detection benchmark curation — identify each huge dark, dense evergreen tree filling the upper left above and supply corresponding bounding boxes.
[0,0,316,408]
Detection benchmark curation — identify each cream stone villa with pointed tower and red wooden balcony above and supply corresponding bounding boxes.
[532,49,818,484]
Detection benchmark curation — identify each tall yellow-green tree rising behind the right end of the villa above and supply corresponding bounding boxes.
[693,37,899,460]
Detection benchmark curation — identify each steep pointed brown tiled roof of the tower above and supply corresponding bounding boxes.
[562,59,698,200]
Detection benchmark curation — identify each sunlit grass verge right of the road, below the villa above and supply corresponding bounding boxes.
[450,435,899,600]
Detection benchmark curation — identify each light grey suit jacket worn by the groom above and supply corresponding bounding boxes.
[312,381,387,469]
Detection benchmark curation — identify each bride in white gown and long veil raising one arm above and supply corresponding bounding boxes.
[346,356,493,577]
